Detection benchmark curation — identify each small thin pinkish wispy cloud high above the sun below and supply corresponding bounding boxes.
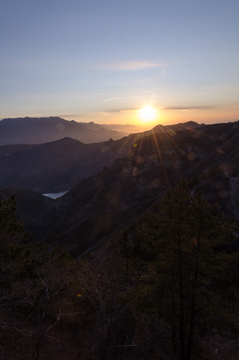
[101,61,169,70]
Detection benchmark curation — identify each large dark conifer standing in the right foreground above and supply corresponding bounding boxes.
[115,181,236,360]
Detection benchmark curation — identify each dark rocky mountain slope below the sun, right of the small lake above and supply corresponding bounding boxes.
[2,122,239,256]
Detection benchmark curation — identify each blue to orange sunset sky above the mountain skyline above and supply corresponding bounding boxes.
[0,0,239,128]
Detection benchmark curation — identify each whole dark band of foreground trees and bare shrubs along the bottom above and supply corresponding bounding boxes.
[0,186,238,360]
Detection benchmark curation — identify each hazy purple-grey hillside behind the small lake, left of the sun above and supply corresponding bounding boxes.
[0,119,204,193]
